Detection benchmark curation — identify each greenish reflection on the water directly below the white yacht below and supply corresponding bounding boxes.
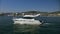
[14,24,40,34]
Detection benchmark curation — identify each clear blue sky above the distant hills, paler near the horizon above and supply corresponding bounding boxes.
[0,0,60,12]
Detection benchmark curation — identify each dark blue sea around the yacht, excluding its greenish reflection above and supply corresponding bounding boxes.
[0,16,60,34]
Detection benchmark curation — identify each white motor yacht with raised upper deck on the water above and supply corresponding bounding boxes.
[13,14,42,25]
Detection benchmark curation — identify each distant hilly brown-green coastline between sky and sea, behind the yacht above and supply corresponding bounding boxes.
[0,11,60,17]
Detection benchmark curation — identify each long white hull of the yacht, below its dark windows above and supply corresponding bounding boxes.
[14,19,41,25]
